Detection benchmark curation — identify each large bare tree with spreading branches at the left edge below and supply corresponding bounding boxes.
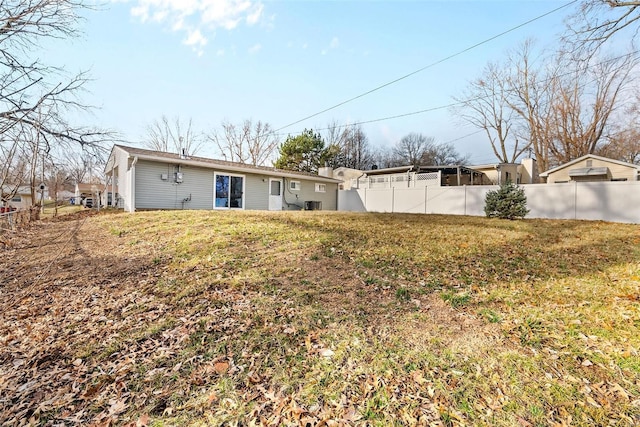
[0,0,113,210]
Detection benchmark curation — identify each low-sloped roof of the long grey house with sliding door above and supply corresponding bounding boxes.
[105,144,342,183]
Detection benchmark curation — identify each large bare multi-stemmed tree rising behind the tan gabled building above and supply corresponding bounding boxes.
[506,42,635,170]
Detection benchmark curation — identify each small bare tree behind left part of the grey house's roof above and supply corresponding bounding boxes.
[145,115,204,155]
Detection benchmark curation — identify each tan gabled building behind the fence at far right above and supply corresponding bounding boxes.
[540,154,640,184]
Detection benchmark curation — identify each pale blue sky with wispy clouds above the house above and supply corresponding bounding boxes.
[42,0,575,163]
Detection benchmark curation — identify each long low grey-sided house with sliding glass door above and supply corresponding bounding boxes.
[105,145,339,212]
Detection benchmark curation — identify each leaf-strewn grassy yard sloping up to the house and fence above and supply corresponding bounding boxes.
[0,211,640,427]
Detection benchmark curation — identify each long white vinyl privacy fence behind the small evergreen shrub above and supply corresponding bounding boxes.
[338,181,640,224]
